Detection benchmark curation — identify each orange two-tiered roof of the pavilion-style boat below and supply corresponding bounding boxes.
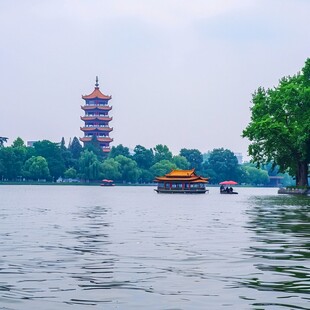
[155,169,209,183]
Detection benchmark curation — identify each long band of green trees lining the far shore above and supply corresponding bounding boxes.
[0,137,292,185]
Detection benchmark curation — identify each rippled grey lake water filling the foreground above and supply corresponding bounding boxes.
[0,185,310,310]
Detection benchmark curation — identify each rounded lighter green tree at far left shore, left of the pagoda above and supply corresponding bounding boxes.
[23,156,50,180]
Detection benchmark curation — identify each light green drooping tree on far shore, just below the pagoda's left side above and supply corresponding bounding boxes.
[79,150,101,181]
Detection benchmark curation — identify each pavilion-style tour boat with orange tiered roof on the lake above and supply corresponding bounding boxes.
[155,169,209,194]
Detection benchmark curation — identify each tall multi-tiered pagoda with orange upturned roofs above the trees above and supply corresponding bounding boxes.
[80,77,113,153]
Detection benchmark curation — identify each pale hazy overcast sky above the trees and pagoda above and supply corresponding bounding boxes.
[0,0,310,158]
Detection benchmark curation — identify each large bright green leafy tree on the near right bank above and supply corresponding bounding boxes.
[243,59,310,186]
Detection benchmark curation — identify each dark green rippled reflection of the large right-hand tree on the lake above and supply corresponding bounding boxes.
[241,196,310,309]
